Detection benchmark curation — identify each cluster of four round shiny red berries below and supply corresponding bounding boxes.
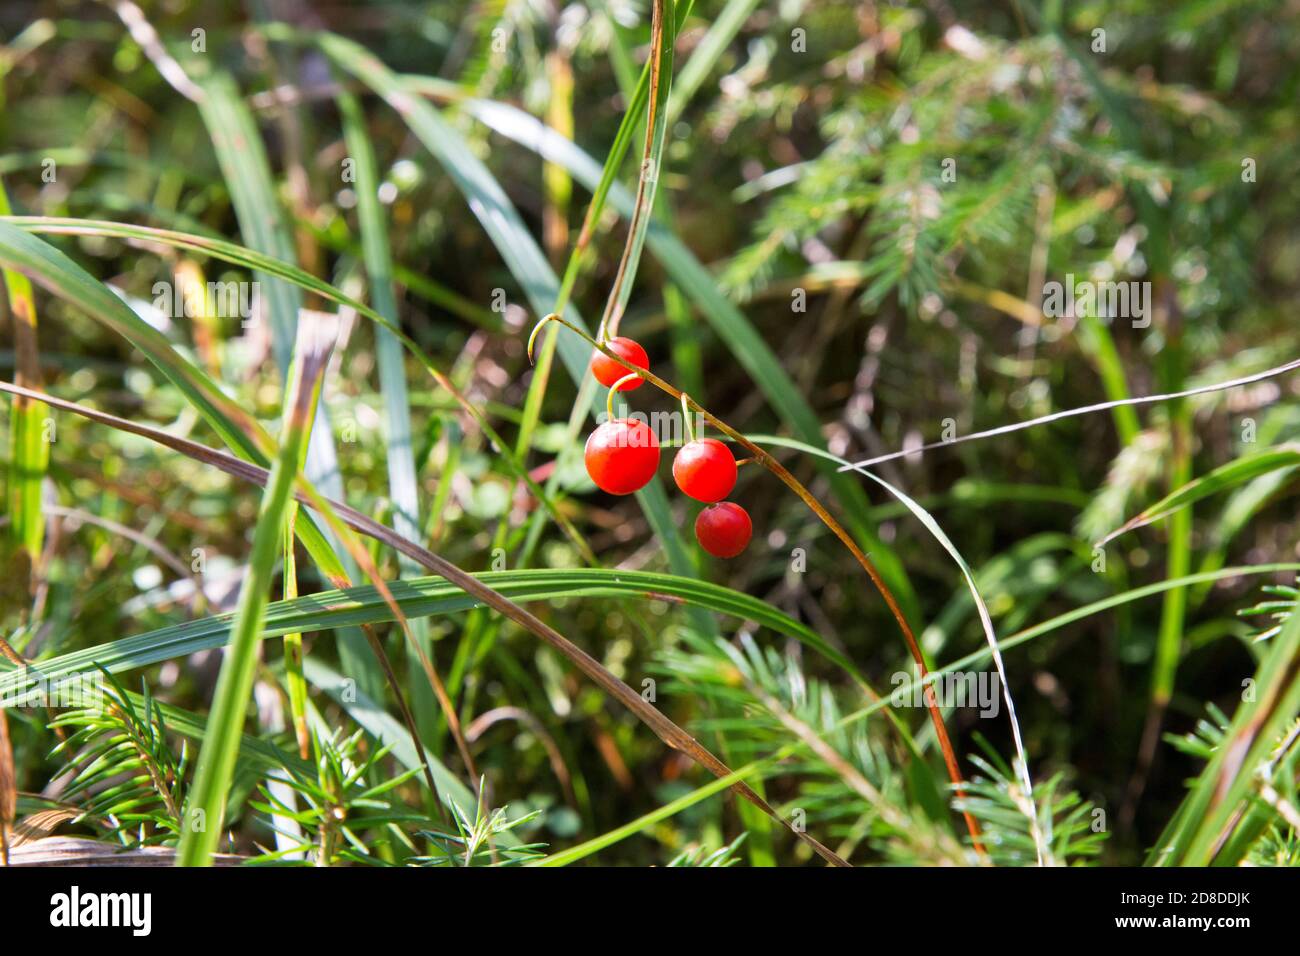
[585,336,754,558]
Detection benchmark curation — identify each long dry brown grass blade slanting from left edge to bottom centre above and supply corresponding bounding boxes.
[0,382,849,866]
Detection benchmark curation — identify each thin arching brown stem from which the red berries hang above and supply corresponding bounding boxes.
[529,312,984,853]
